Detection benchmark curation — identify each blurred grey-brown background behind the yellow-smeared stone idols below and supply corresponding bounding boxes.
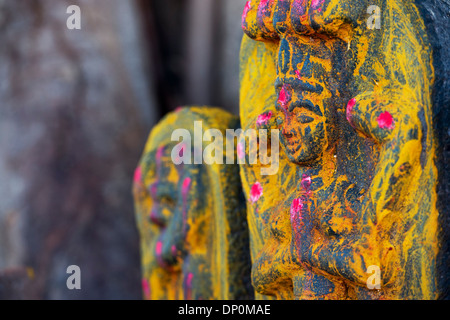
[0,0,245,299]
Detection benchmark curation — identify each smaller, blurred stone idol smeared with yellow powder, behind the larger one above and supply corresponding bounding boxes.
[134,107,253,300]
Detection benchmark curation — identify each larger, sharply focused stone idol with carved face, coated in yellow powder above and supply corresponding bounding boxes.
[241,0,448,299]
